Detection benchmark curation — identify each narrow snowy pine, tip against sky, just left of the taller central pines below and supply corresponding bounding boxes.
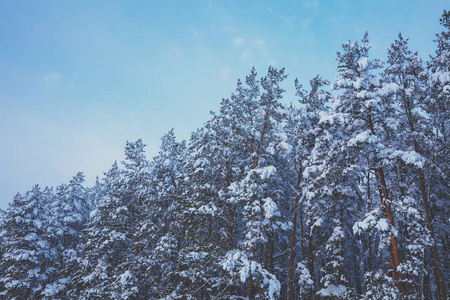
[148,129,188,299]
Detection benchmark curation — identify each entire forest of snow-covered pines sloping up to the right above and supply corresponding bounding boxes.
[0,11,450,299]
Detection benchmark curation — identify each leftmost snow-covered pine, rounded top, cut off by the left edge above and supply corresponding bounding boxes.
[0,185,53,300]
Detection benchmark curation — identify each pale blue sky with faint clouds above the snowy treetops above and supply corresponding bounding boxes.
[0,0,450,209]
